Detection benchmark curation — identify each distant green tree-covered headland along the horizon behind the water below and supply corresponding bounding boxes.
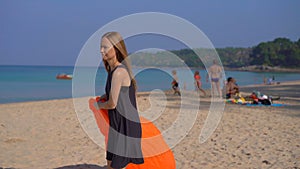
[132,38,300,68]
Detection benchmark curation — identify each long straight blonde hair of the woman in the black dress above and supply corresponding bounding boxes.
[102,32,137,90]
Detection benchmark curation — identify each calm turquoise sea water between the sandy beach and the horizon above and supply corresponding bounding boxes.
[0,66,300,103]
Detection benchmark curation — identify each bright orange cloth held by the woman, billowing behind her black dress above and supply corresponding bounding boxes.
[89,99,176,169]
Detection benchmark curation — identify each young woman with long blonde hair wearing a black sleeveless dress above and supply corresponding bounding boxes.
[97,32,144,168]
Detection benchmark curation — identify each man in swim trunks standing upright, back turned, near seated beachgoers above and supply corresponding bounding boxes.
[206,60,222,97]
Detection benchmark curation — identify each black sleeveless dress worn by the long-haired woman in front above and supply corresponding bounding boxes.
[105,65,144,168]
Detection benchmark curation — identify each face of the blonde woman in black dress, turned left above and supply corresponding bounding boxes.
[100,37,116,61]
